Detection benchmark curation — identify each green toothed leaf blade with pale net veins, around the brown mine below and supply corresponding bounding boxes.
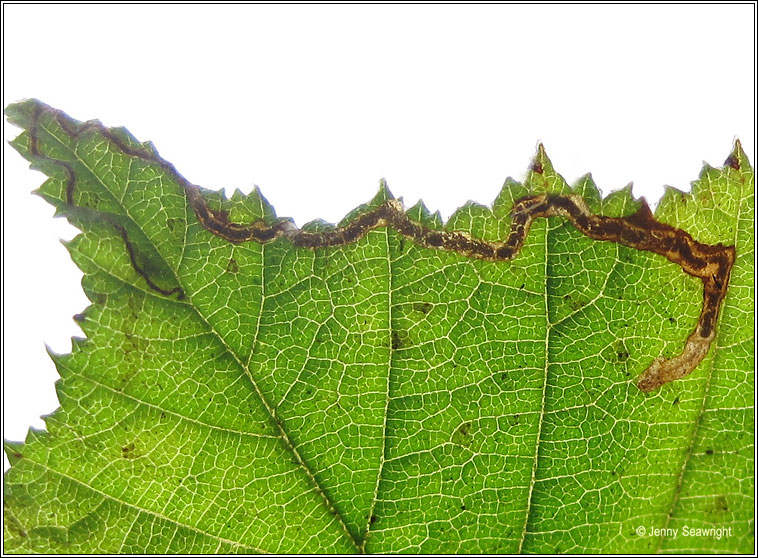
[4,100,754,554]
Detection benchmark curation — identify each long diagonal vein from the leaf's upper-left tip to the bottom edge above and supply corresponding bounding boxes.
[32,120,360,550]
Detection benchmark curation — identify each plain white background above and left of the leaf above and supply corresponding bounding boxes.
[3,4,755,472]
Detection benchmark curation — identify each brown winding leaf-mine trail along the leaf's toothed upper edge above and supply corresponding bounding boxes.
[29,103,739,392]
